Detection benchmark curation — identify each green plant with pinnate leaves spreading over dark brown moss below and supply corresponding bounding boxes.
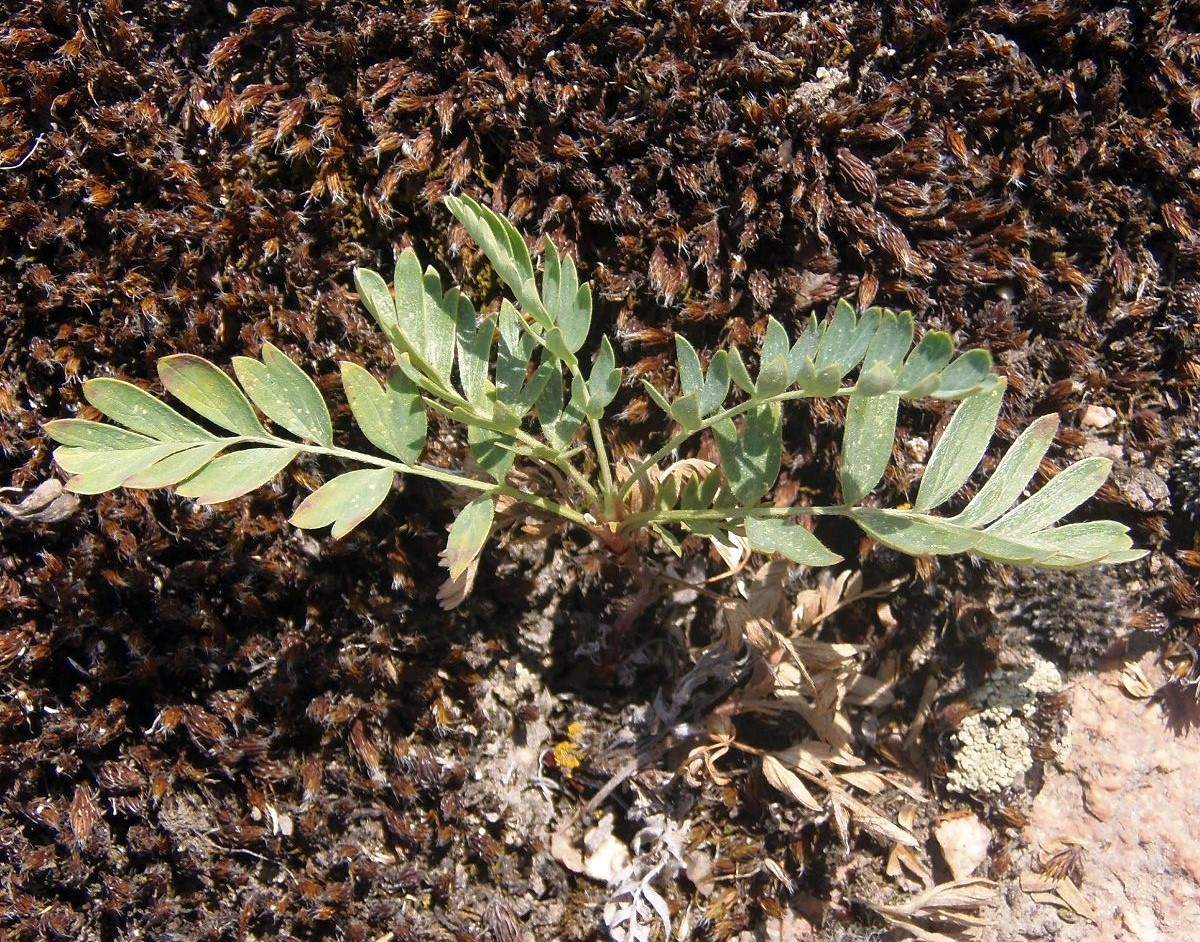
[46,197,1142,605]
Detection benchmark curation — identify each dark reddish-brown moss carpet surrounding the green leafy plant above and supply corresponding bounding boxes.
[0,0,1200,942]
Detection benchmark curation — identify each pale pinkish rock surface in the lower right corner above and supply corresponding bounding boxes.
[998,665,1200,942]
